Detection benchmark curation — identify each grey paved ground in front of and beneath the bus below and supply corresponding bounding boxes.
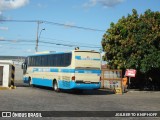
[0,81,160,120]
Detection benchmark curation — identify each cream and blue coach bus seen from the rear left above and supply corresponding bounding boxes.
[22,50,101,91]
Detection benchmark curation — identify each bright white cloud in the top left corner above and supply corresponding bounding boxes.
[0,0,29,13]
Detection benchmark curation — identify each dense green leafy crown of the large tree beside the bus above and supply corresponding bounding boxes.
[102,9,160,73]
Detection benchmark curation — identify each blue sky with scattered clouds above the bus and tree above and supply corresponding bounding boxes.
[0,0,160,56]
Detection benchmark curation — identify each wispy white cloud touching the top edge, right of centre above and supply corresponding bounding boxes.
[83,0,124,8]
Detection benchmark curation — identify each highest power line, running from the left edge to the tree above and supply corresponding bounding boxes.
[0,20,105,32]
